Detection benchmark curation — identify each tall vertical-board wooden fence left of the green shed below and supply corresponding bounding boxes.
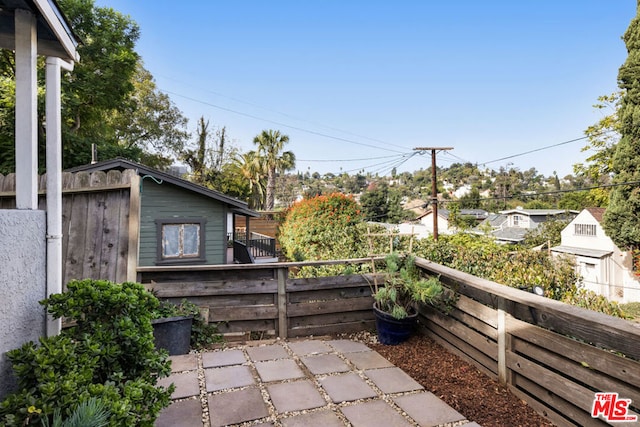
[0,170,139,283]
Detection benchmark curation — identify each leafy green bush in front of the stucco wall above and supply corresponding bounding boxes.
[0,280,173,426]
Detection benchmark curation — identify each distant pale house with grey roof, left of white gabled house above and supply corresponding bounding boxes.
[474,208,578,243]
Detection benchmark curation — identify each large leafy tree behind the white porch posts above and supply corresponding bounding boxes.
[0,0,189,173]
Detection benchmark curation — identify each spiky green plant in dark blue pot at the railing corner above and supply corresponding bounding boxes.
[372,253,444,345]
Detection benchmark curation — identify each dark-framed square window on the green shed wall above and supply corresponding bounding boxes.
[156,218,205,264]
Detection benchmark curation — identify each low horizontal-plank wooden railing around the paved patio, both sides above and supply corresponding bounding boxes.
[138,258,640,426]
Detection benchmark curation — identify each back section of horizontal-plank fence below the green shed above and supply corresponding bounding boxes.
[138,260,382,338]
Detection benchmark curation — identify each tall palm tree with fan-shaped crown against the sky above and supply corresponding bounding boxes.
[253,129,296,211]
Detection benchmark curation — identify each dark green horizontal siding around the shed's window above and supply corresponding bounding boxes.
[138,179,227,266]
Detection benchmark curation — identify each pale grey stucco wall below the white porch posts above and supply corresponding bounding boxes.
[0,210,46,399]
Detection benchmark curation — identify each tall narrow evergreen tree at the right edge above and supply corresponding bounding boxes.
[603,4,640,250]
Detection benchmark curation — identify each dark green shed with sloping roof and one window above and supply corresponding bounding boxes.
[68,159,259,267]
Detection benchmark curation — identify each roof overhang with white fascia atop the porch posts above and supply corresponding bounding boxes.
[0,0,80,62]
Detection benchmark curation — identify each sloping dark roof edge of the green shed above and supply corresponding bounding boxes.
[67,159,260,217]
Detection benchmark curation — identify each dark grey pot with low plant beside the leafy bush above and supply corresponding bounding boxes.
[151,300,199,356]
